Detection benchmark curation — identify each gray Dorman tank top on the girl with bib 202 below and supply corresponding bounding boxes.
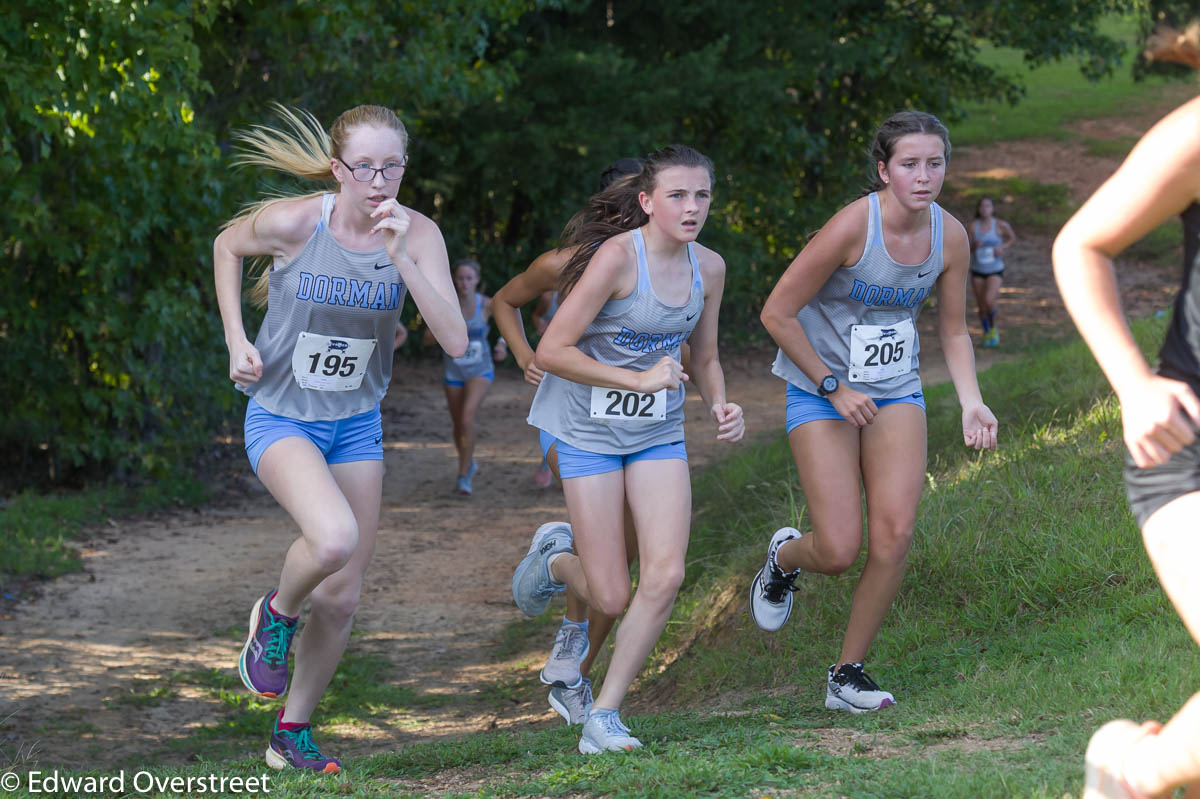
[526,229,704,455]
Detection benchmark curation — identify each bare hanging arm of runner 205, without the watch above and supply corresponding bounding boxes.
[937,212,998,450]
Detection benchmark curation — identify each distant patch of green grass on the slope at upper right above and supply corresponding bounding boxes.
[952,17,1195,146]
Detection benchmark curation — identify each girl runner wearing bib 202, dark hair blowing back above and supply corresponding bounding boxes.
[512,145,744,753]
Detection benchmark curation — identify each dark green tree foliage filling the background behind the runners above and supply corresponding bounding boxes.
[0,0,1133,475]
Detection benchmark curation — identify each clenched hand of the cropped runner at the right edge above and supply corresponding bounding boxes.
[1121,374,1200,469]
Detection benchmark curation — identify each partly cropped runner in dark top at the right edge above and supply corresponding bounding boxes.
[1054,24,1200,799]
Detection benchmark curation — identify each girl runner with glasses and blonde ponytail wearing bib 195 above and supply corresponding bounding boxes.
[212,106,467,774]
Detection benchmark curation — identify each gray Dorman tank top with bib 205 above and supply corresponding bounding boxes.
[770,193,944,400]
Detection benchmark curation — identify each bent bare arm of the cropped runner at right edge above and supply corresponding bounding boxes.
[1054,98,1200,468]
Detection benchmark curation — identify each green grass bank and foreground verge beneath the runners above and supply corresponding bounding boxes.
[9,319,1200,799]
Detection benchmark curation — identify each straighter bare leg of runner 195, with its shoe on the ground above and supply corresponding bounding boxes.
[283,453,384,722]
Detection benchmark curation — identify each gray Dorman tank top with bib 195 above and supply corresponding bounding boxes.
[241,194,406,421]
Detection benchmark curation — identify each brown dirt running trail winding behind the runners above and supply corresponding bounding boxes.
[0,113,1176,770]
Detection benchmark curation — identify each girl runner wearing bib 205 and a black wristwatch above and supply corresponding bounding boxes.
[750,112,997,713]
